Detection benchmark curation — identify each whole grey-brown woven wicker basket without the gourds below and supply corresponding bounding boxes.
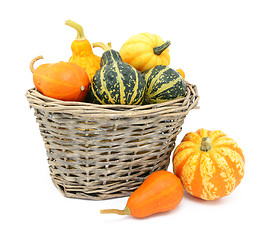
[26,84,199,200]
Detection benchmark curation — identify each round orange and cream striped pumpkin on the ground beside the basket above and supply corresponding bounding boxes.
[173,129,245,200]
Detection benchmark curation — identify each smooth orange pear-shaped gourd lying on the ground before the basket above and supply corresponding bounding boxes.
[100,170,183,218]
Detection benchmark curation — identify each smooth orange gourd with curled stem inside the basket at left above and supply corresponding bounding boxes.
[30,56,89,101]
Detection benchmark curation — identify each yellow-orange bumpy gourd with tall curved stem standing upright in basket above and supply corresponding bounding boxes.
[65,20,101,82]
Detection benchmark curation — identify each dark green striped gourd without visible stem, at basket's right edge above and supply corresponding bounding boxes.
[144,65,187,104]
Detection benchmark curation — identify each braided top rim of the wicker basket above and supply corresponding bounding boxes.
[25,82,200,115]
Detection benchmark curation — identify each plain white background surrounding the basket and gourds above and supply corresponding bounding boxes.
[0,0,269,240]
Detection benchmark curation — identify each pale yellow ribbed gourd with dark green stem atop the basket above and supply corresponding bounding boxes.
[120,33,171,72]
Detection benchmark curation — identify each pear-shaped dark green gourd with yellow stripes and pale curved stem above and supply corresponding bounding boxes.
[90,42,146,105]
